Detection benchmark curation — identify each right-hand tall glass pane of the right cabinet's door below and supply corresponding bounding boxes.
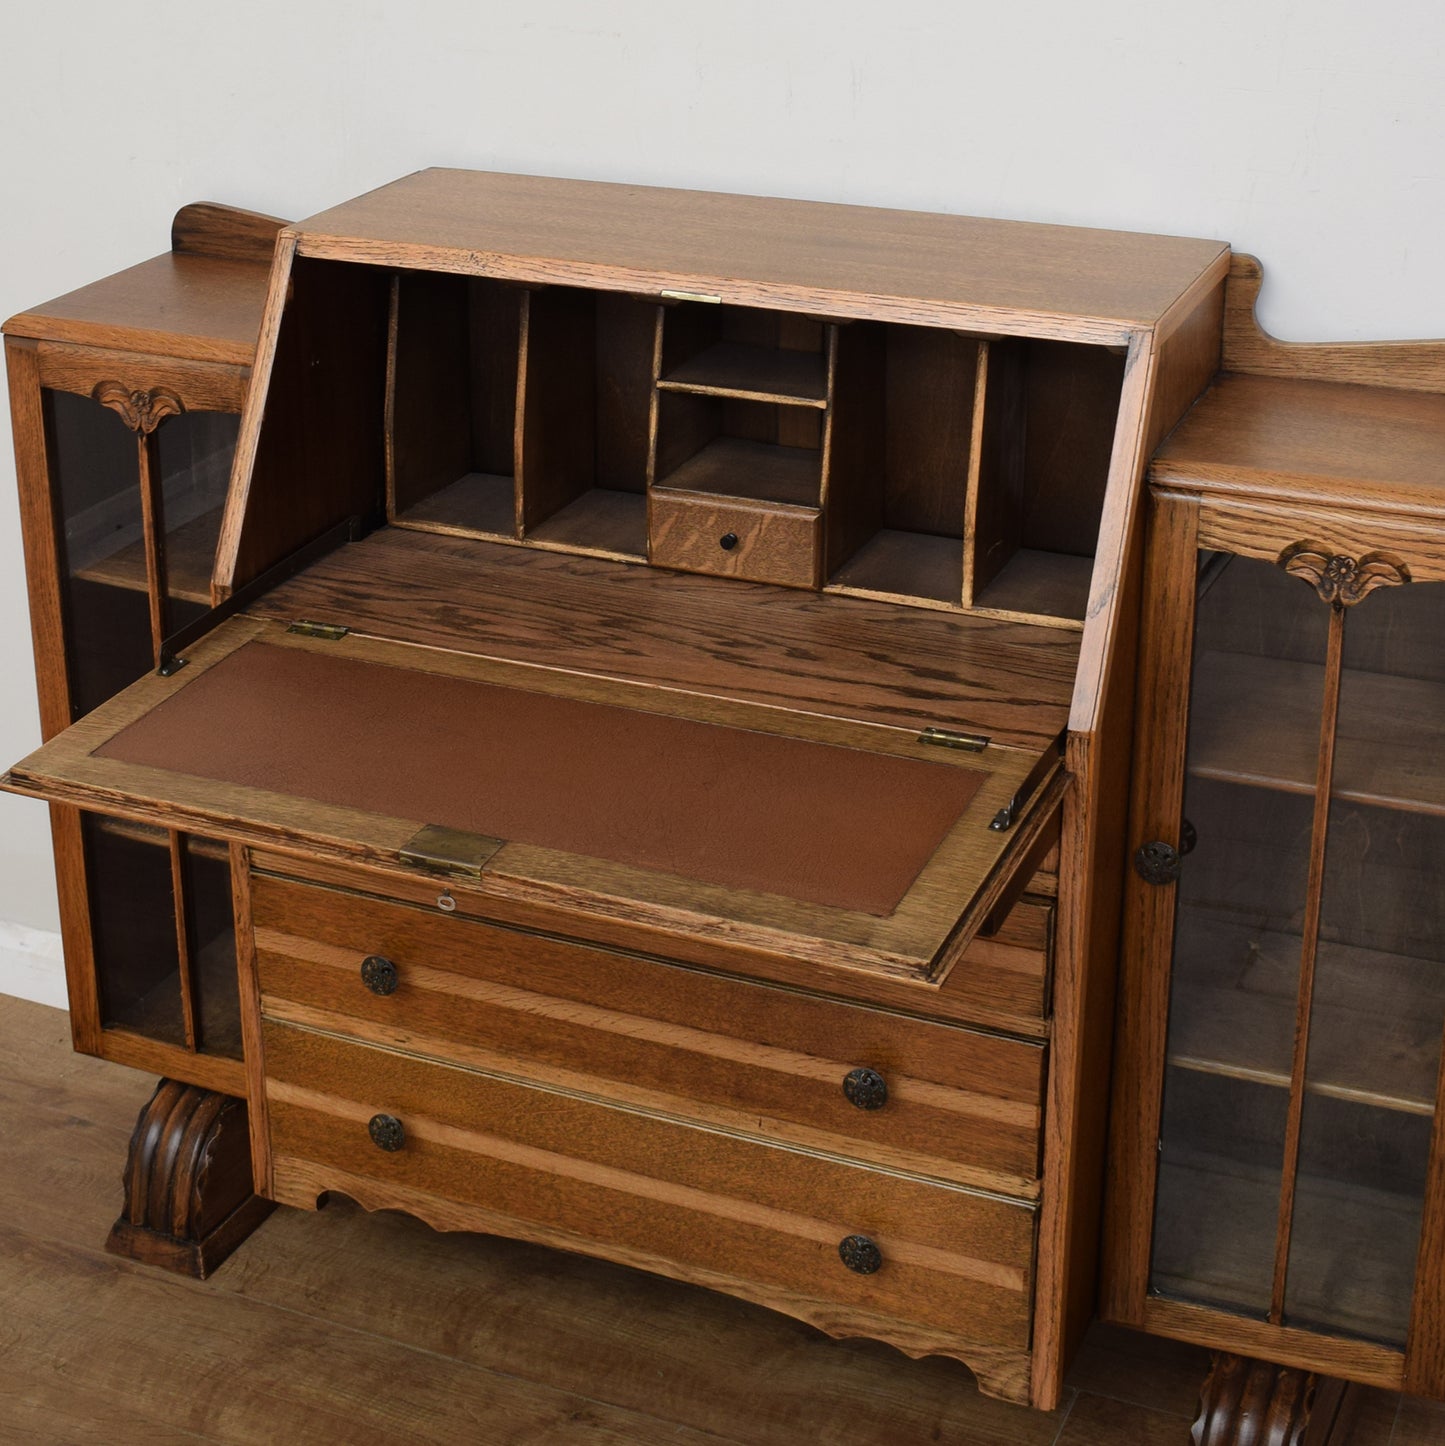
[1286,584,1445,1346]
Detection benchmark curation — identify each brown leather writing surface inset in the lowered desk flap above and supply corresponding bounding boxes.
[95,643,986,915]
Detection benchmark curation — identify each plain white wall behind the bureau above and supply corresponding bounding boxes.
[0,0,1445,991]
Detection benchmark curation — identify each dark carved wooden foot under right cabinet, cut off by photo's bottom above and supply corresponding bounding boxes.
[1193,1351,1360,1446]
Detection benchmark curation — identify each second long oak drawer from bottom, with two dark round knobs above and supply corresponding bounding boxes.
[252,875,1044,1194]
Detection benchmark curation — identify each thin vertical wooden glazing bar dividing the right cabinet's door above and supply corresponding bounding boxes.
[1270,604,1345,1326]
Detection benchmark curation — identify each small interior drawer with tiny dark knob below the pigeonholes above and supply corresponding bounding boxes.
[651,487,822,587]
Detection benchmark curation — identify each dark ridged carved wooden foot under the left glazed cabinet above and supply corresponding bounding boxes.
[106,1080,275,1280]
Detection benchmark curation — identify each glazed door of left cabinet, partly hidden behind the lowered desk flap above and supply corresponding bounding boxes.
[7,340,246,1083]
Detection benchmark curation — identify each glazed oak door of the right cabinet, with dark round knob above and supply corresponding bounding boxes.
[1107,496,1445,1391]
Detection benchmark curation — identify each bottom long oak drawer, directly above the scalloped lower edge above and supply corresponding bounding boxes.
[265,1021,1034,1349]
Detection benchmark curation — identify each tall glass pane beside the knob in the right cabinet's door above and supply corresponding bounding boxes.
[1151,555,1329,1317]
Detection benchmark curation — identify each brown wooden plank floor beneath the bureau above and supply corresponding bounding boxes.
[0,996,1445,1446]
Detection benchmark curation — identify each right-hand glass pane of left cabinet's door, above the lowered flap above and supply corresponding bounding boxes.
[156,412,240,635]
